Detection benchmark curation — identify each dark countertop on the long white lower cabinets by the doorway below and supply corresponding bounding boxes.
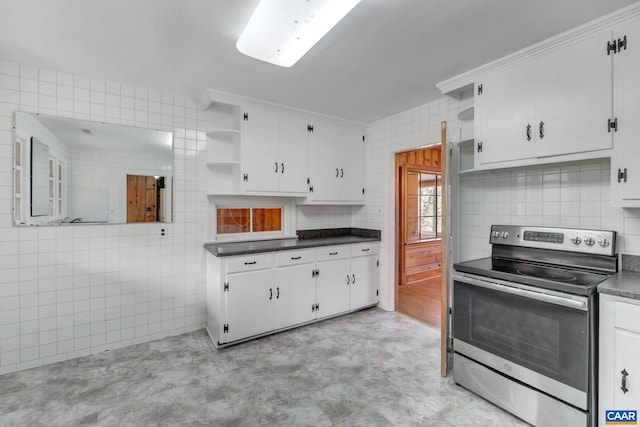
[204,228,380,257]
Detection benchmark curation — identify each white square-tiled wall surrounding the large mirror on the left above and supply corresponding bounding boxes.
[0,61,207,374]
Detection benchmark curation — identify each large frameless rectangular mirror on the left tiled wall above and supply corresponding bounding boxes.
[14,112,173,225]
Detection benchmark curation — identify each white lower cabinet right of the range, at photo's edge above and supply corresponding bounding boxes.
[598,294,640,426]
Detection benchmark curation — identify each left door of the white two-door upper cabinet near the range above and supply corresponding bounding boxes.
[474,61,535,165]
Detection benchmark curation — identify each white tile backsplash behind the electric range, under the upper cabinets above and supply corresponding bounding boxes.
[459,159,640,260]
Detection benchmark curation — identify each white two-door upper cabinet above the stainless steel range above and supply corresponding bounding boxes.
[475,31,612,167]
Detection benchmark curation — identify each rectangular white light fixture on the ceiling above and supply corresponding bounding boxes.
[236,0,360,67]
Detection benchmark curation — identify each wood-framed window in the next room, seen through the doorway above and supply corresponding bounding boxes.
[406,171,442,242]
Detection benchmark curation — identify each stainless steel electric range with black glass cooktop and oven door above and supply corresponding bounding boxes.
[453,225,618,426]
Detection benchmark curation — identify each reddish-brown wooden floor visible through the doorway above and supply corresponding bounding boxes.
[396,276,441,329]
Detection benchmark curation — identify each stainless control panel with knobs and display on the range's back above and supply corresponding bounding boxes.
[489,225,616,256]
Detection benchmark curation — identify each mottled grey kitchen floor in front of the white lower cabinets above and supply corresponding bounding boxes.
[0,309,525,427]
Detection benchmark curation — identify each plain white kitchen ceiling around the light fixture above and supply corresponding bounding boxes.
[0,0,635,123]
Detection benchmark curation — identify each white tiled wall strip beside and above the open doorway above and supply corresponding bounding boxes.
[352,97,460,310]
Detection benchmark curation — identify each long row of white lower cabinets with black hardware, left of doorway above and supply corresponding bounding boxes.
[207,242,379,346]
